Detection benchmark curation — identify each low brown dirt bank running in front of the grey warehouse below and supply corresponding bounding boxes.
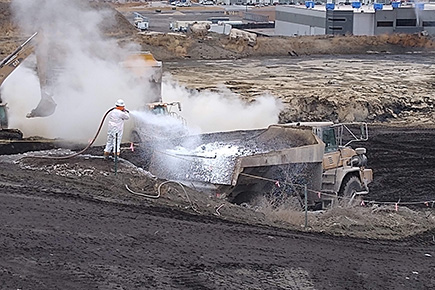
[136,27,435,61]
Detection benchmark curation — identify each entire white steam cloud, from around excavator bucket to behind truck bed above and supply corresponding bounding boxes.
[2,0,282,144]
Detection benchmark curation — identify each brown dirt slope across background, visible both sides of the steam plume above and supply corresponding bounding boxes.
[0,2,435,61]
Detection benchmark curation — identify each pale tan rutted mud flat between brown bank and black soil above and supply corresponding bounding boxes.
[164,53,435,124]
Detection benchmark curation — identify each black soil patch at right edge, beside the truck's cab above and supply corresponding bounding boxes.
[362,125,435,202]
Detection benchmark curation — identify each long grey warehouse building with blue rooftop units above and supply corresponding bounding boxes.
[275,1,435,36]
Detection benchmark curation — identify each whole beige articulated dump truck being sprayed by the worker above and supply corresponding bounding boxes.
[149,122,373,208]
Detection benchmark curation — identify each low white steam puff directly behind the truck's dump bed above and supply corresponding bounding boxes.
[162,77,283,133]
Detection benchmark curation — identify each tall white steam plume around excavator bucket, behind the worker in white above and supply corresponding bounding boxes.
[3,0,153,144]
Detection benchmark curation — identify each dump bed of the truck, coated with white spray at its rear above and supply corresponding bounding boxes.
[149,125,324,199]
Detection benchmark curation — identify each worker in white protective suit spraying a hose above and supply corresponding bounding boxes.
[104,99,130,159]
